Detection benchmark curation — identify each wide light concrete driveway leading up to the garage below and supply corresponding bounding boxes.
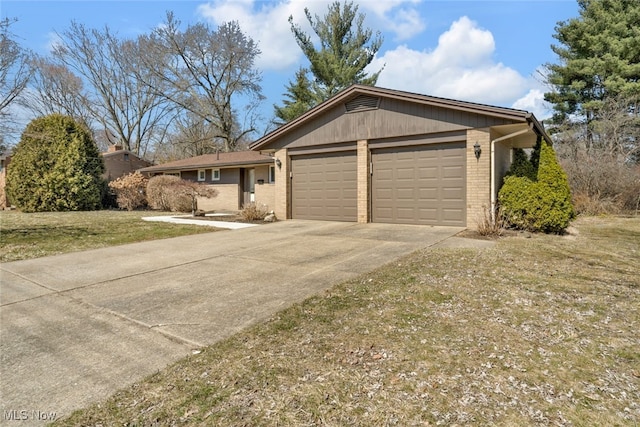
[0,221,470,425]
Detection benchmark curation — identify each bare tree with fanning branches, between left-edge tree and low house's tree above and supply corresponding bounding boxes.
[53,22,174,157]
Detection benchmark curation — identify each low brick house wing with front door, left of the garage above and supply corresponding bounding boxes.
[139,151,275,211]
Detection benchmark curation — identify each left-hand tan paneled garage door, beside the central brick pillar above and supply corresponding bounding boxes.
[291,151,357,221]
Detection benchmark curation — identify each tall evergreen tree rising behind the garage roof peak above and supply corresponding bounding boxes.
[275,1,382,122]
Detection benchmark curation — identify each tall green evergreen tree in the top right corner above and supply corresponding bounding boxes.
[545,0,640,123]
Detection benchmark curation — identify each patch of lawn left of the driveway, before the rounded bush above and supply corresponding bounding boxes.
[0,210,218,262]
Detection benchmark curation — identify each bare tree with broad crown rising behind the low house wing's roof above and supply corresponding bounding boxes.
[142,12,263,151]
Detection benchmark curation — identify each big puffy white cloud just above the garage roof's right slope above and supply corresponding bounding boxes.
[370,16,527,105]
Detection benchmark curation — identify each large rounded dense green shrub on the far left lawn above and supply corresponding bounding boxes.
[7,114,106,212]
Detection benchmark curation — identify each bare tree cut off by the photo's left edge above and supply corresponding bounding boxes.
[0,18,33,151]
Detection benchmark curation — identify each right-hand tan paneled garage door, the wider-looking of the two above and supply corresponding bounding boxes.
[371,142,466,226]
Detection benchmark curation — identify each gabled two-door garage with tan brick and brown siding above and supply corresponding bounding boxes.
[250,85,548,227]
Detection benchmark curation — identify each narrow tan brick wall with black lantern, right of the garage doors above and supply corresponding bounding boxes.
[467,128,491,228]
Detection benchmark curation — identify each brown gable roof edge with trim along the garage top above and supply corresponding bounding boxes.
[249,84,551,150]
